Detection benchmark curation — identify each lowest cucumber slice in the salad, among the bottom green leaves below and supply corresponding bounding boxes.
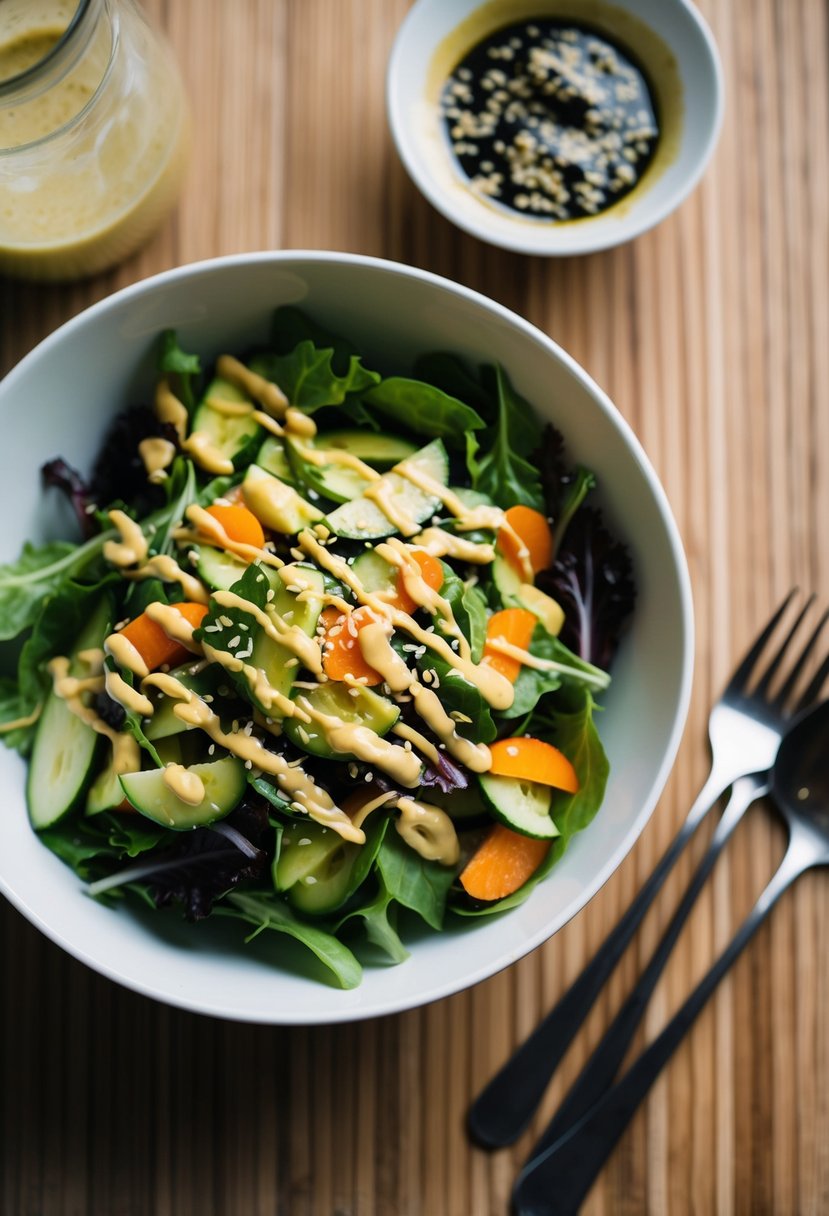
[273,818,361,916]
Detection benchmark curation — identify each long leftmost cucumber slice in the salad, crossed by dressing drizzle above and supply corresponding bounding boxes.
[26,596,113,831]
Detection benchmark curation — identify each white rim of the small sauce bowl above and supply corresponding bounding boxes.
[385,0,724,258]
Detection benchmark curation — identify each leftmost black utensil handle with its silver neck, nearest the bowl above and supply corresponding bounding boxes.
[468,772,728,1148]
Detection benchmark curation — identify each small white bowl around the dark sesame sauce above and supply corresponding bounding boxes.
[387,0,723,257]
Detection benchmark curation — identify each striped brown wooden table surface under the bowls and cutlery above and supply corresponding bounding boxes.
[0,0,829,1216]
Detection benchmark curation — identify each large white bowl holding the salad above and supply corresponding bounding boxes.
[0,253,693,1024]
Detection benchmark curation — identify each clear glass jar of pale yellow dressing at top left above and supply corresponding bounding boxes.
[0,0,187,280]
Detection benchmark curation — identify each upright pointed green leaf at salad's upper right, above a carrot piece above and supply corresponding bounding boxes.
[473,367,545,511]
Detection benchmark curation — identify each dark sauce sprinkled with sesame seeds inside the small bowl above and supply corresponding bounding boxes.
[440,18,659,221]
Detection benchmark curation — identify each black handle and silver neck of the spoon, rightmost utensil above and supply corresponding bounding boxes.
[513,845,802,1216]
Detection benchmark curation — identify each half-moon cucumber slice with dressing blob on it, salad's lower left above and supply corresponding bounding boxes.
[120,756,248,832]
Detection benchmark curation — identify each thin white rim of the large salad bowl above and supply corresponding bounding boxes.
[0,249,694,1025]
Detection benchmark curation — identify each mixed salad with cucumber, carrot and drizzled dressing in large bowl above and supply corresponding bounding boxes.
[0,308,635,987]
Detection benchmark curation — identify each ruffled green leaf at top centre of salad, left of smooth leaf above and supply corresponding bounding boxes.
[250,340,380,413]
